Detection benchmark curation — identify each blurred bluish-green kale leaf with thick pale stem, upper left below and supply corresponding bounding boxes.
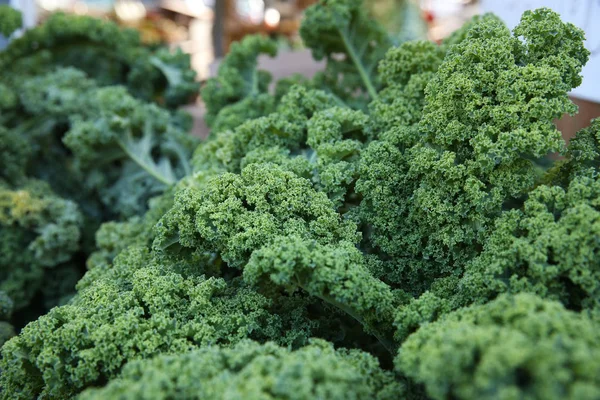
[4,67,197,222]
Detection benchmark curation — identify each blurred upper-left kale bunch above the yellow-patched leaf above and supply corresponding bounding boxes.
[0,9,199,228]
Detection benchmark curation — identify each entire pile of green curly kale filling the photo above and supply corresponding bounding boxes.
[0,0,600,400]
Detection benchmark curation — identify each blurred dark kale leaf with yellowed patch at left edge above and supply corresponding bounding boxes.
[0,180,83,310]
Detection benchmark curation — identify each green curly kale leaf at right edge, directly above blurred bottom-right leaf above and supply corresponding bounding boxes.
[458,176,600,310]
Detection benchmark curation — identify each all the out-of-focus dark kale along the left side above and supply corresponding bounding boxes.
[0,6,198,341]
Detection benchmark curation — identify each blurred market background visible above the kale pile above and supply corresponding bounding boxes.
[0,0,600,139]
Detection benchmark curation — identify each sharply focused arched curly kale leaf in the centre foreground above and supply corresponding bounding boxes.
[154,164,394,351]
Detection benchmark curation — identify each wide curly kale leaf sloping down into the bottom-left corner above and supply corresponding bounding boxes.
[0,246,324,399]
